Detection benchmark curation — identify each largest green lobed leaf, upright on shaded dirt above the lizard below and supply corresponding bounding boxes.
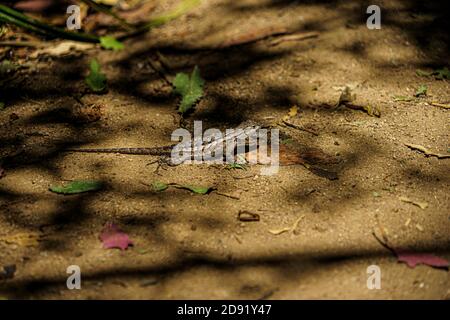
[173,66,205,113]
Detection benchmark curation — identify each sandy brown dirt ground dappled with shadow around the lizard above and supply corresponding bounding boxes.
[0,0,450,299]
